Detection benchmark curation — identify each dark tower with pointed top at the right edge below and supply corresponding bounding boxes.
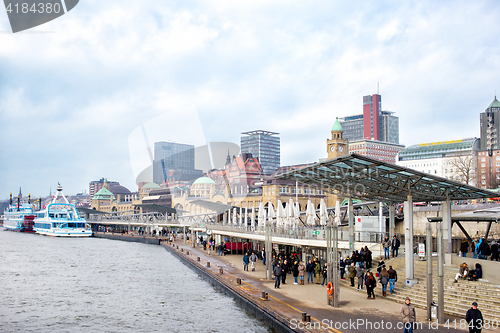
[479,96,500,150]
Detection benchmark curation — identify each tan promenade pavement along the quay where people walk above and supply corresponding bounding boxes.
[168,240,500,333]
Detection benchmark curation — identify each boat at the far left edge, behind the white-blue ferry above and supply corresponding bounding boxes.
[3,193,35,232]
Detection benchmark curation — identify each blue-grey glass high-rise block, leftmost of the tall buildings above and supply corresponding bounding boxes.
[153,142,203,184]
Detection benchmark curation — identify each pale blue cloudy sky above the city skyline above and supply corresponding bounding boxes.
[0,0,500,199]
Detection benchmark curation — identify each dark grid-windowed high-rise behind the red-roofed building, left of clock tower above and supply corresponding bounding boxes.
[241,130,281,175]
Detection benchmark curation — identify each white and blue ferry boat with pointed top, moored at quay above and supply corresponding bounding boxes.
[33,184,92,237]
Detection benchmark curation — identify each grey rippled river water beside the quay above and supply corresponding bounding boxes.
[0,231,269,333]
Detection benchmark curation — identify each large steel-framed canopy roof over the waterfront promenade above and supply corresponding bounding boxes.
[277,154,499,202]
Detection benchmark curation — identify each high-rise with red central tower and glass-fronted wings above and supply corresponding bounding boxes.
[339,94,399,144]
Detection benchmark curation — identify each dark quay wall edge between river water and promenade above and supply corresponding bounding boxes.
[161,243,307,332]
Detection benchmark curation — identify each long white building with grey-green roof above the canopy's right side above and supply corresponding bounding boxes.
[396,138,480,185]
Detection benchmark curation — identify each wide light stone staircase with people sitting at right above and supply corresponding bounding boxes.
[356,257,500,324]
